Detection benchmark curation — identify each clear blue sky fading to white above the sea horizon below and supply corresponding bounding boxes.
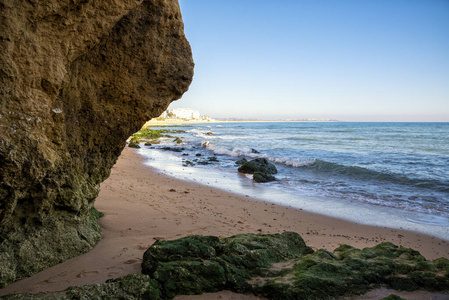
[174,0,449,122]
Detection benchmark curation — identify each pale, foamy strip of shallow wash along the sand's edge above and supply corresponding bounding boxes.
[138,147,449,241]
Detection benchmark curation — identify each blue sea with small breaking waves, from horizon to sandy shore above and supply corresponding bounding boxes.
[139,122,449,240]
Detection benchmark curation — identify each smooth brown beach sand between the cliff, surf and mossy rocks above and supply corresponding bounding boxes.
[0,148,449,299]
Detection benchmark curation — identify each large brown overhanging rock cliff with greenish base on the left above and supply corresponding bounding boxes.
[0,0,193,287]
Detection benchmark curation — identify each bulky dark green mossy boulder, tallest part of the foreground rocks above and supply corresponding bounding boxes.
[142,232,313,297]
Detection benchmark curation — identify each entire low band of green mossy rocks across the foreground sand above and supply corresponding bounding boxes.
[6,232,449,299]
